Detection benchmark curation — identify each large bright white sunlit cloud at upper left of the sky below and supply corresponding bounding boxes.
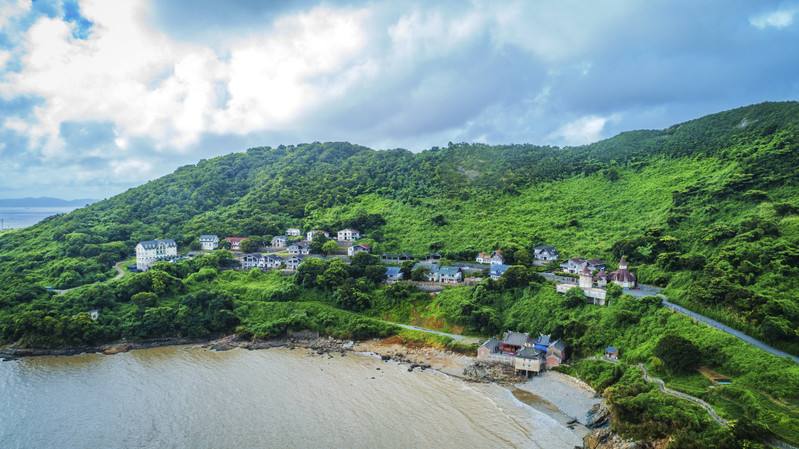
[0,0,374,158]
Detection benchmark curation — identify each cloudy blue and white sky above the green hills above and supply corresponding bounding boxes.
[0,0,799,198]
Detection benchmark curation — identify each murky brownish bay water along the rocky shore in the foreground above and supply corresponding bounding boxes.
[0,346,581,449]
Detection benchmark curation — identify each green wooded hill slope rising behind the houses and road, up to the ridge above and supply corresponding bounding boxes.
[0,102,799,353]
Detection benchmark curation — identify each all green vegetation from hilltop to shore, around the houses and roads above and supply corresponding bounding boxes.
[0,102,799,448]
